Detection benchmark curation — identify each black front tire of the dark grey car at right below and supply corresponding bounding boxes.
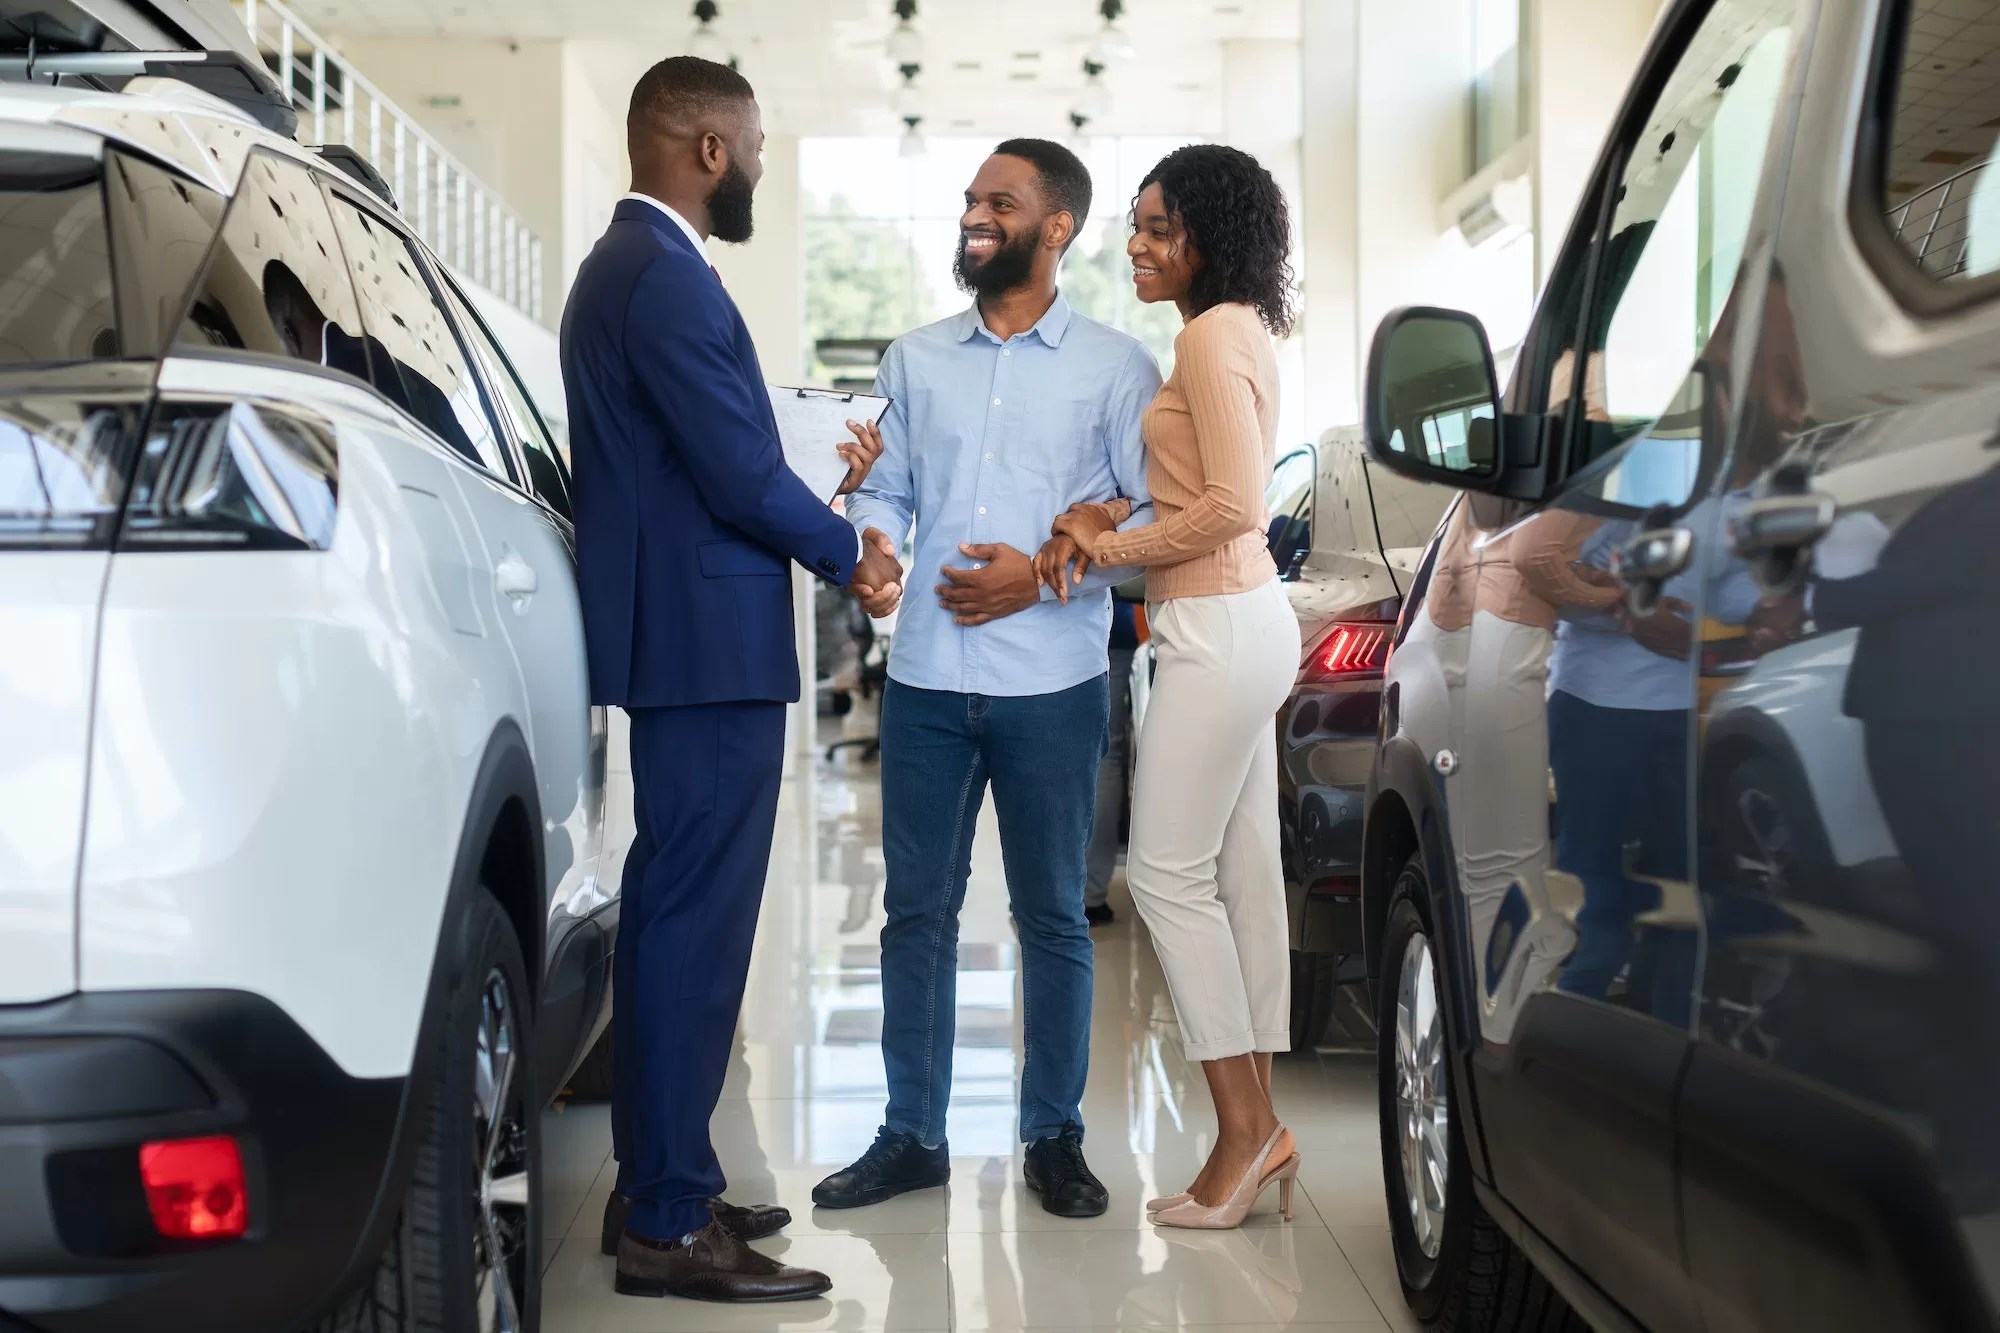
[1376,855,1586,1333]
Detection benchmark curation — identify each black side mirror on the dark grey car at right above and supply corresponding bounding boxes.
[1362,306,1506,490]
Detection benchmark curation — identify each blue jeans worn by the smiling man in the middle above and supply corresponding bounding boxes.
[882,677,1110,1147]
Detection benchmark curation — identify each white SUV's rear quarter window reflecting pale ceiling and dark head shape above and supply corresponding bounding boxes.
[176,152,368,380]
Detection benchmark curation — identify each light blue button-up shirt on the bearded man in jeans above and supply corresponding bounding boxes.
[846,294,1160,697]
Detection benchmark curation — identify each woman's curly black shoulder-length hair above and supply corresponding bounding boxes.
[1130,144,1294,336]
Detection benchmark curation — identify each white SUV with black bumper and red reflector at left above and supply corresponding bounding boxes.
[0,78,618,1333]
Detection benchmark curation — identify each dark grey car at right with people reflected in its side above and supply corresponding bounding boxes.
[1362,0,2000,1333]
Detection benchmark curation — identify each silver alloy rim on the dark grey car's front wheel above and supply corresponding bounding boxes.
[1396,931,1452,1259]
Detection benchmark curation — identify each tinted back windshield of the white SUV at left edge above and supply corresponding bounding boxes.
[0,148,122,362]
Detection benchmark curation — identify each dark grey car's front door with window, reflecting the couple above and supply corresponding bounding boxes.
[1430,0,1792,1329]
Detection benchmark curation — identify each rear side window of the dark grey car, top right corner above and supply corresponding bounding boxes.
[1882,4,2000,282]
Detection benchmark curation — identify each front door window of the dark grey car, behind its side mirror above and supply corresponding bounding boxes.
[1546,0,1794,470]
